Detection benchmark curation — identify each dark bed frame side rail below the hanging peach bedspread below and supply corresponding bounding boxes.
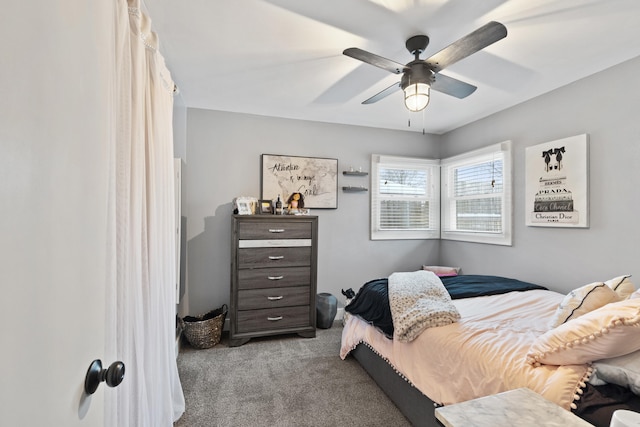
[350,343,443,427]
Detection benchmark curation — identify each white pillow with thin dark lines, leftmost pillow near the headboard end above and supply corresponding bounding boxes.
[549,282,620,329]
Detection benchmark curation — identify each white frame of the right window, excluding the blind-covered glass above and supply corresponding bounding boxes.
[441,141,513,246]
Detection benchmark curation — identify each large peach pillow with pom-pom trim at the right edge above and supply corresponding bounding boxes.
[527,298,640,366]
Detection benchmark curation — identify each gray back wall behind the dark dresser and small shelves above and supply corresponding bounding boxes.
[181,109,440,314]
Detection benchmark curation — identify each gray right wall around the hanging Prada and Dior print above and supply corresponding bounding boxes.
[440,58,640,292]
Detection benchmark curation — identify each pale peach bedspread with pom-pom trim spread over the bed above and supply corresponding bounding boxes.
[340,290,591,409]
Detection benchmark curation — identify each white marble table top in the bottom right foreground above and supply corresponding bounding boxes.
[436,388,591,427]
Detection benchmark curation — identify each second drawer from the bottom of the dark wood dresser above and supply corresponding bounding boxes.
[238,286,309,310]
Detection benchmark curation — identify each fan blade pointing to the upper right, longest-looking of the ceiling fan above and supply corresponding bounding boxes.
[426,21,507,73]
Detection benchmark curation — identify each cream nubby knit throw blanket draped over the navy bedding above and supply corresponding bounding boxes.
[389,270,460,342]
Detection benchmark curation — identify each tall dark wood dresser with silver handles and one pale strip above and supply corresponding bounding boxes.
[229,215,318,347]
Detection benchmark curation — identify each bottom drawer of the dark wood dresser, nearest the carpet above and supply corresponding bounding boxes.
[237,306,311,333]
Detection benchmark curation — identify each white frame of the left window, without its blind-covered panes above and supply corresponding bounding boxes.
[370,154,440,240]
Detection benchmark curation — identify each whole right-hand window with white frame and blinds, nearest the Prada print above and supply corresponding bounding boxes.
[442,141,512,245]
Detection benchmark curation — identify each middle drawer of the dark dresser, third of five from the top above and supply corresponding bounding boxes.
[238,267,311,289]
